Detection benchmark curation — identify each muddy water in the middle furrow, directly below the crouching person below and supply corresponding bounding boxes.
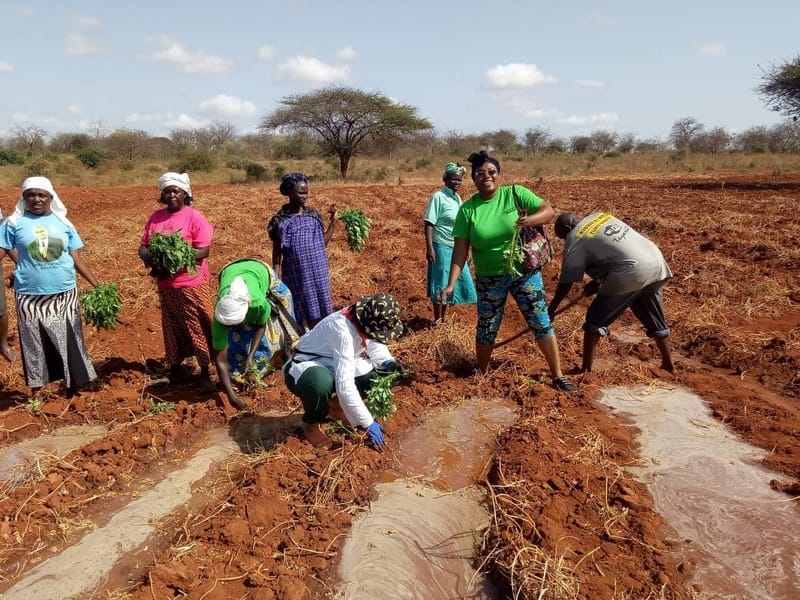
[337,398,515,600]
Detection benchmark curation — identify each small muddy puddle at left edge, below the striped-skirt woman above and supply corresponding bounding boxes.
[0,425,108,484]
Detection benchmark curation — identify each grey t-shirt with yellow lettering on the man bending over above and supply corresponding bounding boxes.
[559,212,672,295]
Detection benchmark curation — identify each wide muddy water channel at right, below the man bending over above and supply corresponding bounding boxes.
[601,387,800,600]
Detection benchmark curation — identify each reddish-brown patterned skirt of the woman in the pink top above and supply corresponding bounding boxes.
[158,282,214,370]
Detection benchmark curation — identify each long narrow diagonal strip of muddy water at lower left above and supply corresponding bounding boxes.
[3,430,239,600]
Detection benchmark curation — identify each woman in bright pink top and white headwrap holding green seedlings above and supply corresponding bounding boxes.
[139,173,214,391]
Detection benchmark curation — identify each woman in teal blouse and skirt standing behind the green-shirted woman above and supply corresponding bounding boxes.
[424,163,477,323]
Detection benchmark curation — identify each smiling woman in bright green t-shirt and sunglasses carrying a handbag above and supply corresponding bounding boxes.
[441,150,576,392]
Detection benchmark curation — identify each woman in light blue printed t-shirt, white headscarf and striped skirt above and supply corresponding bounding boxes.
[0,177,103,397]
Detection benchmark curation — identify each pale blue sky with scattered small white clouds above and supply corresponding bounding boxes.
[0,0,800,139]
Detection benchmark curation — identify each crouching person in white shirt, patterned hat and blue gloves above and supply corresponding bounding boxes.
[283,294,404,448]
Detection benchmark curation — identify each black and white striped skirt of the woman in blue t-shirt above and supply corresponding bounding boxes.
[15,287,97,388]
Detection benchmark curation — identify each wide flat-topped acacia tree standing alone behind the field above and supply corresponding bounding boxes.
[259,86,433,179]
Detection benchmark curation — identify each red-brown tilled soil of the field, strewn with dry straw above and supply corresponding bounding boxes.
[0,173,800,600]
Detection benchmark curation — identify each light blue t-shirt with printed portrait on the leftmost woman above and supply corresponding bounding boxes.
[0,212,83,296]
